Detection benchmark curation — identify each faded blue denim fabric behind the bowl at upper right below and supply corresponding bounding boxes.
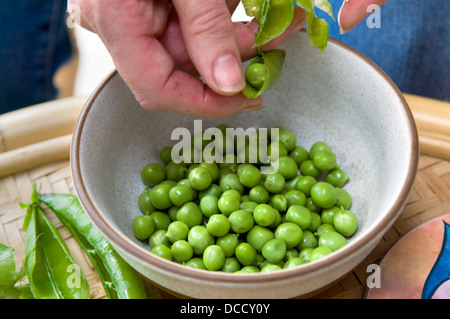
[317,0,450,101]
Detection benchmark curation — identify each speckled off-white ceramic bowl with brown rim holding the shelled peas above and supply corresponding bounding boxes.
[71,32,418,298]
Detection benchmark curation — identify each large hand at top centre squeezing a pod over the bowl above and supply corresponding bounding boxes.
[69,0,305,117]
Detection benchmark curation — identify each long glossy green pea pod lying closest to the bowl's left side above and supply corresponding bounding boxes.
[39,194,147,299]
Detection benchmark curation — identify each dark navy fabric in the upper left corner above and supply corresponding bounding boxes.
[0,0,72,113]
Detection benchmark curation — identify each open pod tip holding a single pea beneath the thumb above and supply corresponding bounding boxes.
[242,49,286,99]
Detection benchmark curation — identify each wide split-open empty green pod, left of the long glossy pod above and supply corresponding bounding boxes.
[25,203,89,299]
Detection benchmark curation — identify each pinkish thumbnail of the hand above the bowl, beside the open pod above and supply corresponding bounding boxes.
[213,54,245,93]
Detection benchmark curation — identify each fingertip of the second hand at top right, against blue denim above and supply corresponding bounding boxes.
[338,0,387,33]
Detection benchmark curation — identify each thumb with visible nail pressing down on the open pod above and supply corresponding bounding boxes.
[172,0,245,95]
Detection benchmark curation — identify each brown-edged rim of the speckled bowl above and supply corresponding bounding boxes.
[70,31,419,284]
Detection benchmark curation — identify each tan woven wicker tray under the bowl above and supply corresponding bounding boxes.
[0,95,450,299]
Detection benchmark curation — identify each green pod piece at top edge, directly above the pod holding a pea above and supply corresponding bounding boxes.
[242,0,294,46]
